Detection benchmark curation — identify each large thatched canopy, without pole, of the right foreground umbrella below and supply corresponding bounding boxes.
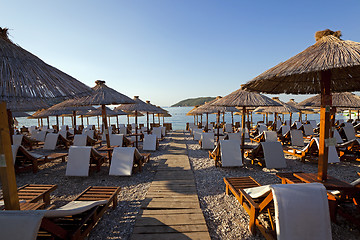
[244,30,360,94]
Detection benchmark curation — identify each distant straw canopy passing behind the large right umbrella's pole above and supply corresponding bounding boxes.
[299,92,360,108]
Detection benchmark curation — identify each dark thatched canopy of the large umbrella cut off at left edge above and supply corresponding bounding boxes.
[0,28,92,104]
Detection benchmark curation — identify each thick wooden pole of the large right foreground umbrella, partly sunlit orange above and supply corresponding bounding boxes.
[318,70,332,181]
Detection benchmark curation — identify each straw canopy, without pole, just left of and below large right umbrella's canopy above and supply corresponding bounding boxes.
[211,88,280,107]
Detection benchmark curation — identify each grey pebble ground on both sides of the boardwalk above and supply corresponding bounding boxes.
[2,133,360,240]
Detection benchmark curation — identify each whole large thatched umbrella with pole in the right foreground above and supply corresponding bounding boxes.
[244,29,360,181]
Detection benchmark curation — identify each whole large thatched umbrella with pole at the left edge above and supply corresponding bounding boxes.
[0,28,91,210]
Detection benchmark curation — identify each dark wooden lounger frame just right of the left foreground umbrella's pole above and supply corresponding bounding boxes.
[14,145,68,173]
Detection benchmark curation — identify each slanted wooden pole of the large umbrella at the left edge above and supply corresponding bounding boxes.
[0,102,20,210]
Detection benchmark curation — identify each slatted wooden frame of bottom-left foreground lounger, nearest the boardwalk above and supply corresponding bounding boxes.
[38,186,120,239]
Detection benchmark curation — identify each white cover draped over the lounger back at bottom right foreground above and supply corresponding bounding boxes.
[244,183,332,240]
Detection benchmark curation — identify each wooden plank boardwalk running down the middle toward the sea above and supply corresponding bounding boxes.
[131,132,210,240]
